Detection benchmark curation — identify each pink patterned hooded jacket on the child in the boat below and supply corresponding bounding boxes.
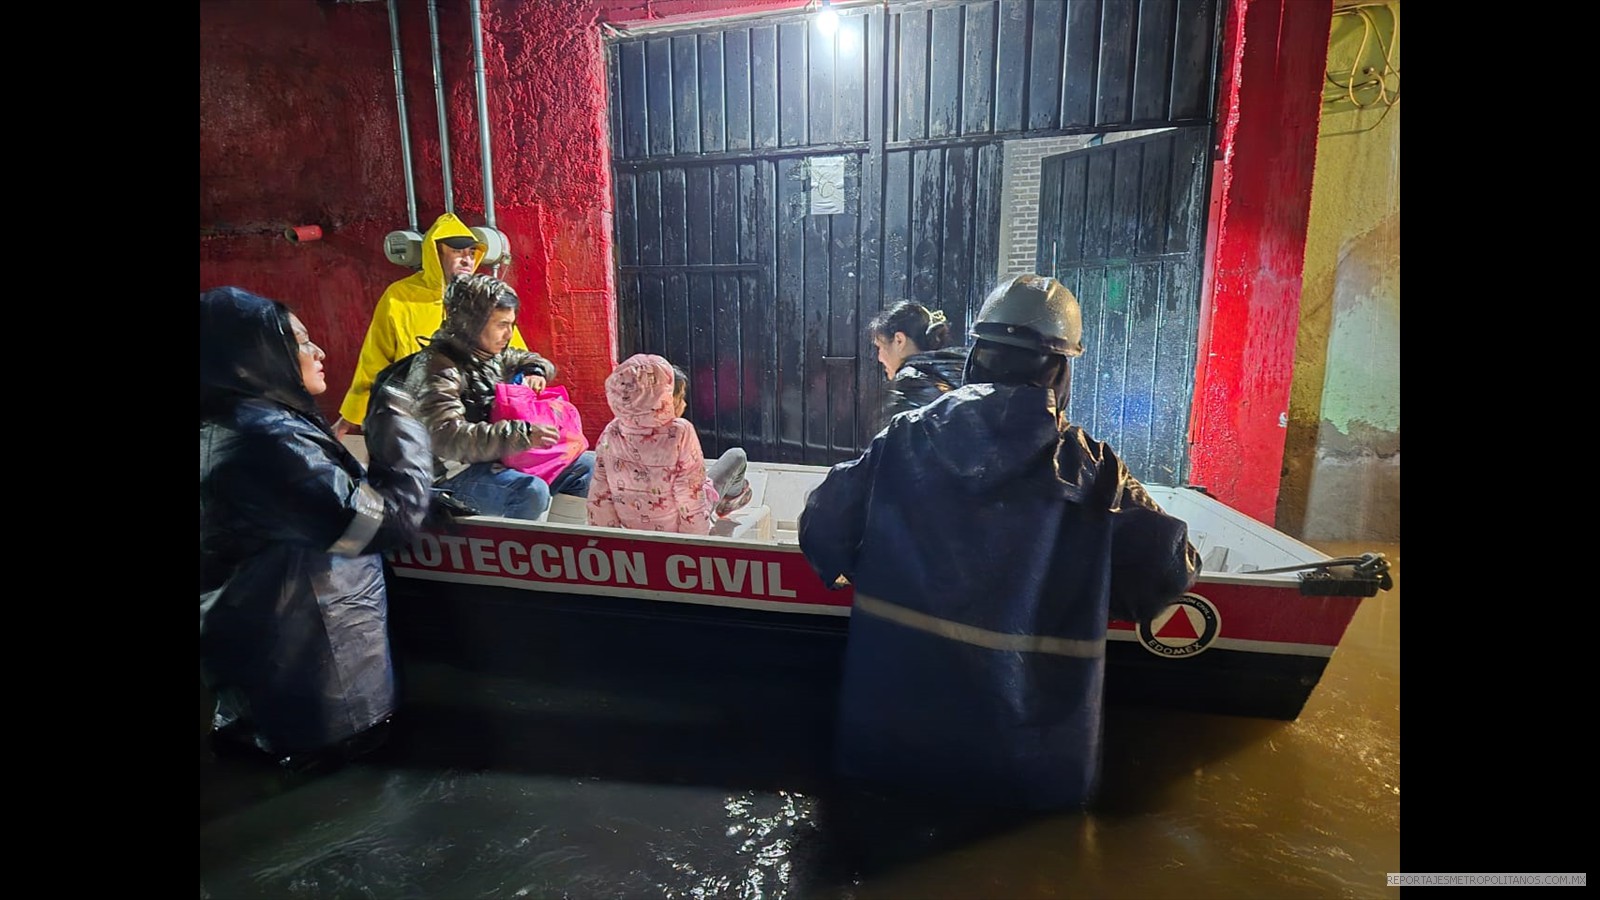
[589,354,715,535]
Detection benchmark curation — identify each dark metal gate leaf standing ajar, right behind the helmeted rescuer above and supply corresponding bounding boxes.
[1035,128,1210,485]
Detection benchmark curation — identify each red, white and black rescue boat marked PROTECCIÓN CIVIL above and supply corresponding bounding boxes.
[374,461,1390,719]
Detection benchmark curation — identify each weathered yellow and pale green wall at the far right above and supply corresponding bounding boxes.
[1277,2,1400,541]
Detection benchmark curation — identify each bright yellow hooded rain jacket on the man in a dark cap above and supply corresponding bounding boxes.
[339,213,528,424]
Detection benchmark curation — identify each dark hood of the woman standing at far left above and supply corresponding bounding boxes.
[200,287,320,420]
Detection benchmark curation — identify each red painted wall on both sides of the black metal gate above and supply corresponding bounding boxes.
[200,0,1331,522]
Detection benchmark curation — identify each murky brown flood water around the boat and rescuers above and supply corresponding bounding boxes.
[200,543,1405,900]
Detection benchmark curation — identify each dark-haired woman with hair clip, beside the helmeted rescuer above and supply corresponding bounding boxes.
[867,299,966,424]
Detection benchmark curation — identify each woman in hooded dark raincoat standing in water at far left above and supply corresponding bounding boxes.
[200,287,432,765]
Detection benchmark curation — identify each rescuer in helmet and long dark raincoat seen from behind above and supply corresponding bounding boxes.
[800,275,1200,809]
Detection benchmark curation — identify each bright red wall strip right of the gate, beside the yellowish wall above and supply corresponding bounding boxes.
[1189,0,1333,525]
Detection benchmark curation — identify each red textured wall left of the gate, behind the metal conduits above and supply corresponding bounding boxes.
[200,0,802,439]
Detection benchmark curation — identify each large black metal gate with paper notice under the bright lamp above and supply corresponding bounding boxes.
[608,0,1219,464]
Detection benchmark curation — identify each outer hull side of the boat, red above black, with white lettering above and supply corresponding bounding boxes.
[390,524,1362,719]
